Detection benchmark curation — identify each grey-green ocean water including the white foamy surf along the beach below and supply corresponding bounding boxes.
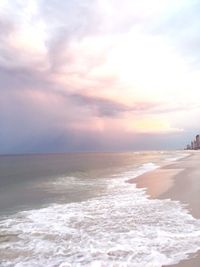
[0,151,200,267]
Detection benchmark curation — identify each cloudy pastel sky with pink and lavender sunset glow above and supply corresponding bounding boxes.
[0,0,200,154]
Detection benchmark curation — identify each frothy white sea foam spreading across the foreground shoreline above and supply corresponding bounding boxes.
[0,163,200,267]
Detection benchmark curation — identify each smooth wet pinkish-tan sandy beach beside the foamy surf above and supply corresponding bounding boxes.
[130,151,200,267]
